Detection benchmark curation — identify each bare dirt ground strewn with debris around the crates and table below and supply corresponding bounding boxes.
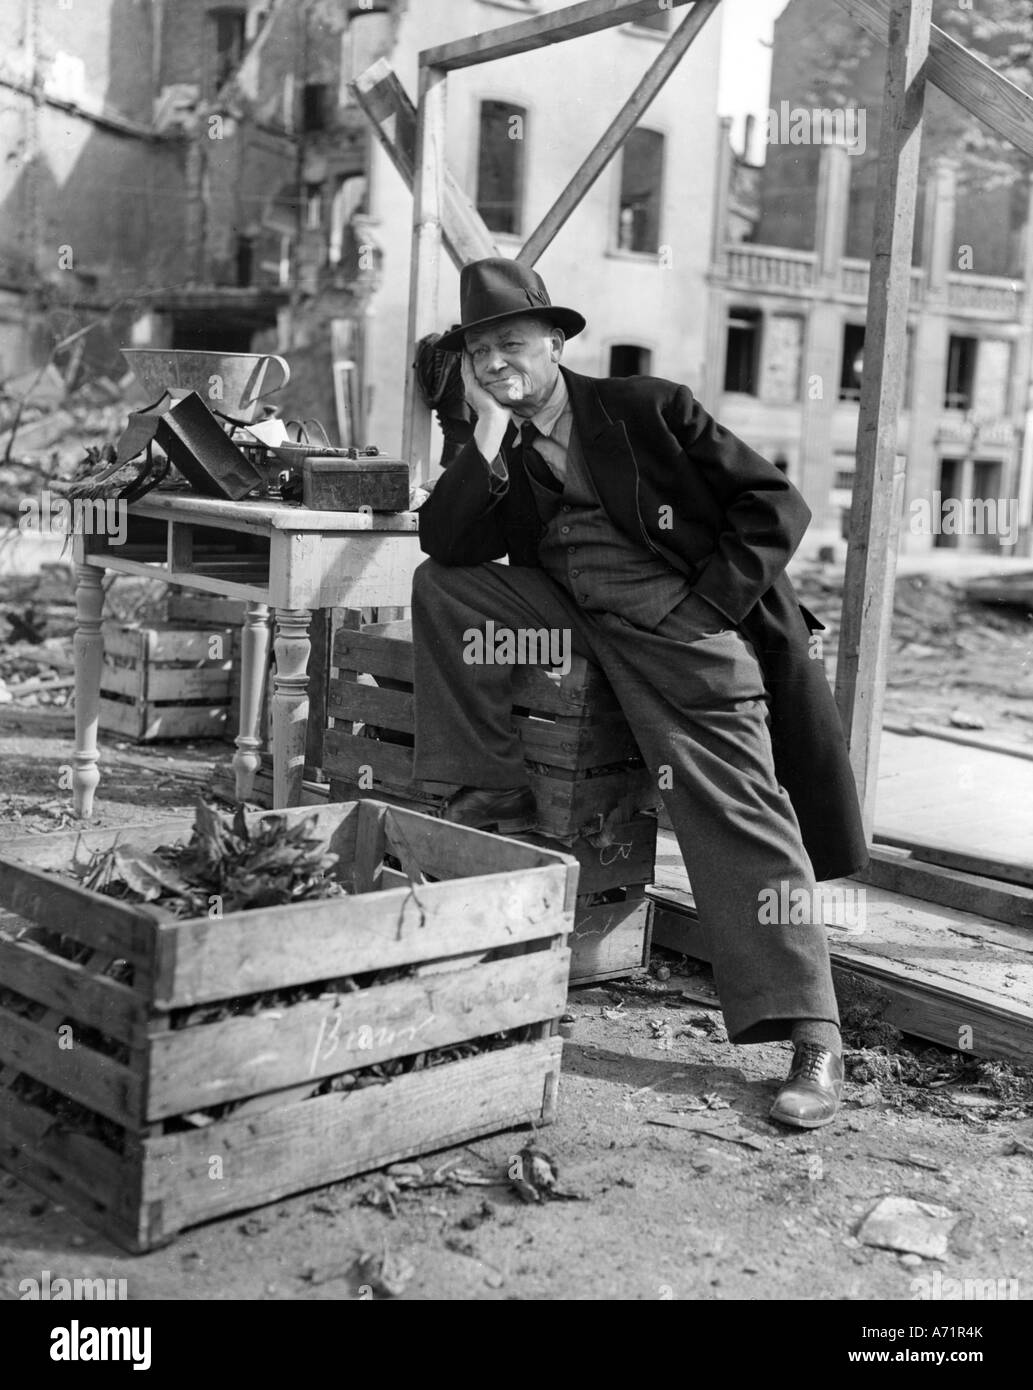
[0,558,1033,1301]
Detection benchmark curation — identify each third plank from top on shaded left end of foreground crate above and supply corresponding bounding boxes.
[0,1006,143,1125]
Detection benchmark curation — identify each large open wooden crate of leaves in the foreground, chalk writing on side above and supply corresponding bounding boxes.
[0,802,578,1251]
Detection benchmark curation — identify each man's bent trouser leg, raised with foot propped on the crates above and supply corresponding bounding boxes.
[413,560,591,788]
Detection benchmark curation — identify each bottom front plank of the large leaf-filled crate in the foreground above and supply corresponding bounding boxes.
[143,1038,560,1236]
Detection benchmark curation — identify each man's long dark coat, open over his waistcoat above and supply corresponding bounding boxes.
[420,367,868,878]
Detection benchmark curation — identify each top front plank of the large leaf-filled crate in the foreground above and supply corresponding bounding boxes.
[154,861,567,1009]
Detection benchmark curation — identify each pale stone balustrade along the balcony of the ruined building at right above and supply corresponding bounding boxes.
[724,242,1025,322]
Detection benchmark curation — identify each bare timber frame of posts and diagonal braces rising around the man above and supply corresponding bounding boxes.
[352,0,1033,867]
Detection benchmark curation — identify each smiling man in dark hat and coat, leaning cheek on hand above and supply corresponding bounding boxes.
[413,259,868,1129]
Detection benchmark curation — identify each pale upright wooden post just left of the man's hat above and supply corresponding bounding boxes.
[402,67,448,482]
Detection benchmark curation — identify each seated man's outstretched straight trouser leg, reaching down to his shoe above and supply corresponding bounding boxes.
[581,609,838,1043]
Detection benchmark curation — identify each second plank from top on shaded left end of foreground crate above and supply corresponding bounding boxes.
[0,931,146,1044]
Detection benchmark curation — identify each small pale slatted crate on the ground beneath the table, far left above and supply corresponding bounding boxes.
[100,623,234,742]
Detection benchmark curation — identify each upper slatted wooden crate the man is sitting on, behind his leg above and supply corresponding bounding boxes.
[323,621,659,837]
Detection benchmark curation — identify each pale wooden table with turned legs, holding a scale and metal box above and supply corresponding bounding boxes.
[72,491,423,817]
